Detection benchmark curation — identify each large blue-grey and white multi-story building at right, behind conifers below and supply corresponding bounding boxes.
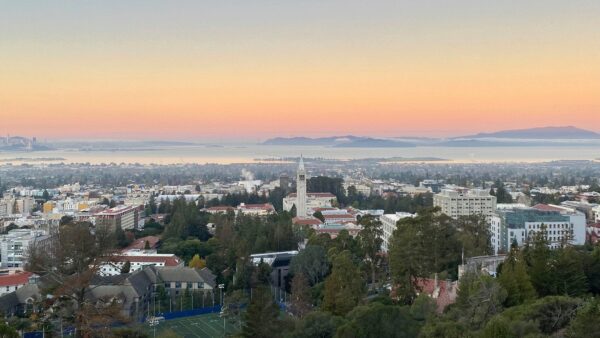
[489,205,586,254]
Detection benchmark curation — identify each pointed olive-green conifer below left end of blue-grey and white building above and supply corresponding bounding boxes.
[498,245,536,306]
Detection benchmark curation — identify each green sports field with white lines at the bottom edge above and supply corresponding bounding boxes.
[145,313,238,338]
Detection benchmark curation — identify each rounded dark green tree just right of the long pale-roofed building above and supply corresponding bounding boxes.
[290,244,329,285]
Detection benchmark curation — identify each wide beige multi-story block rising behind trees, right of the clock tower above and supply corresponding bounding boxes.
[433,189,496,218]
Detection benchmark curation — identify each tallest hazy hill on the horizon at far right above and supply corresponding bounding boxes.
[456,126,600,140]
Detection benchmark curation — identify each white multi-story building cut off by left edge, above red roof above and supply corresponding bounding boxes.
[0,229,50,268]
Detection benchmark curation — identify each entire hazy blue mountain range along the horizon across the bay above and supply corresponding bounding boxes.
[262,126,600,148]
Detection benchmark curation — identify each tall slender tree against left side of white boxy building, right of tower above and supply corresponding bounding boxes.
[358,216,383,283]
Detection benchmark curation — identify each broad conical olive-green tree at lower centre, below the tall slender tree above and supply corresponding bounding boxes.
[323,251,364,315]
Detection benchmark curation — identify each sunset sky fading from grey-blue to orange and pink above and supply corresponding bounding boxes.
[0,0,600,140]
